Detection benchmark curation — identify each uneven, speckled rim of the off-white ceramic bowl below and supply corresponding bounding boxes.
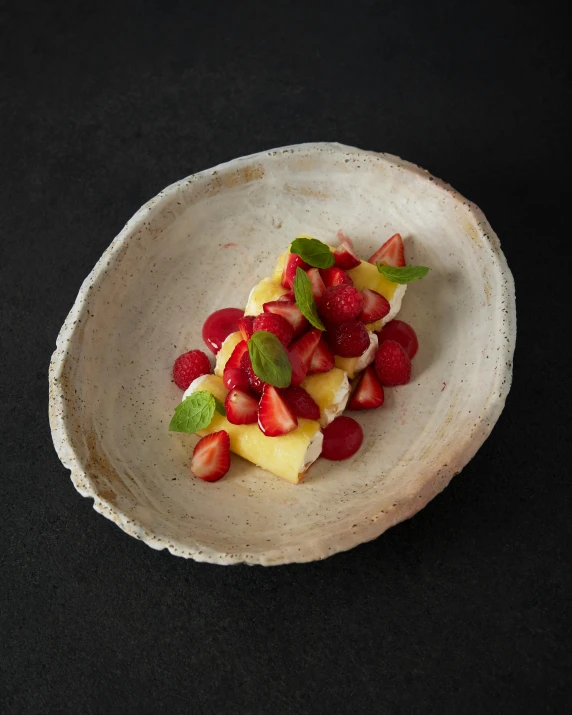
[49,142,516,566]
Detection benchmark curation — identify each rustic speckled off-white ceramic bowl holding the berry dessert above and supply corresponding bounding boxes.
[50,144,516,565]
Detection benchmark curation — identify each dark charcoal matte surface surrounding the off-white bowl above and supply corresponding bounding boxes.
[0,0,572,715]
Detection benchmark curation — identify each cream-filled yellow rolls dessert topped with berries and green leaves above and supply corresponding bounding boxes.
[169,231,429,484]
